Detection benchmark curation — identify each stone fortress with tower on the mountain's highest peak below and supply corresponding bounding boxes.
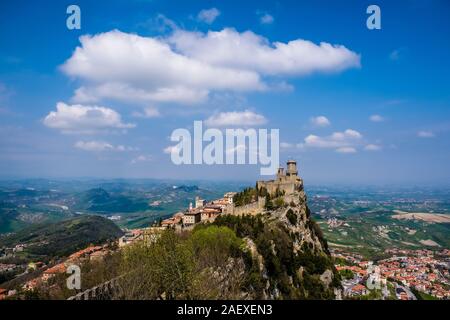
[256,160,303,195]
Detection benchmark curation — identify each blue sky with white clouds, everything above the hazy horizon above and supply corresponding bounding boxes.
[0,0,450,184]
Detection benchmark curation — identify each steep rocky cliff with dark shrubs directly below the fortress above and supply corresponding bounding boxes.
[237,188,340,299]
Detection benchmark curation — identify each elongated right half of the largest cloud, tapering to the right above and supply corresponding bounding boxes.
[169,28,360,76]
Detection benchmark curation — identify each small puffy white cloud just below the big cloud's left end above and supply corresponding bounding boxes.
[44,102,135,134]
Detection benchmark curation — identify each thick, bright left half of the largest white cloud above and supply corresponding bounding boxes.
[61,30,265,103]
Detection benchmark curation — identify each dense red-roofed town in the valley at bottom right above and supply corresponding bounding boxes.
[332,249,450,300]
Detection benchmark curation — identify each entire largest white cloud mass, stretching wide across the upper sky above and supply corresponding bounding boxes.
[61,29,360,104]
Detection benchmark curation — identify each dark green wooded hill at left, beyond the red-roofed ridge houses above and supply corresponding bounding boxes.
[0,215,122,258]
